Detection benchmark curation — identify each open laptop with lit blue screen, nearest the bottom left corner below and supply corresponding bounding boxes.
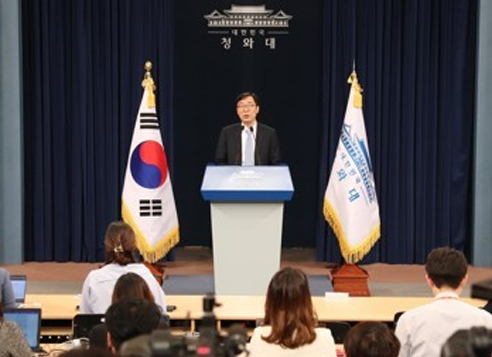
[3,309,46,353]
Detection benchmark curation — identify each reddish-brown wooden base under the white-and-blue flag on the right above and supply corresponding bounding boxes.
[331,263,371,296]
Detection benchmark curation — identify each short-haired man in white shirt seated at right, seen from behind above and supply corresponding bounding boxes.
[395,247,492,357]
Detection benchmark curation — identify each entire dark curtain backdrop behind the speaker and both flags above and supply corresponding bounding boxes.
[23,0,477,263]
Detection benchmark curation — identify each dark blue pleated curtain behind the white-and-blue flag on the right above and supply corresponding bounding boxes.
[316,0,477,263]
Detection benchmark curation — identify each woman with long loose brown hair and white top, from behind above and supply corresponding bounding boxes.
[249,267,336,357]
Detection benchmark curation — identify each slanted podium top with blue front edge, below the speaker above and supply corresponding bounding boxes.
[201,166,294,202]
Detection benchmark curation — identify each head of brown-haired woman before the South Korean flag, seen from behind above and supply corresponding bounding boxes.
[104,221,137,265]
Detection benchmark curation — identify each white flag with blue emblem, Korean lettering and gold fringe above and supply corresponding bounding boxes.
[323,71,381,263]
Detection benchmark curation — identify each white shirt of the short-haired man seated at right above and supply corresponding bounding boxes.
[395,291,492,357]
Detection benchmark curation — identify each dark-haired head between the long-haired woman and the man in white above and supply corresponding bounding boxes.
[343,321,400,357]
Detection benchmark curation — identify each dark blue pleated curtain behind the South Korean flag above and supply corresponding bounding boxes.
[22,0,173,261]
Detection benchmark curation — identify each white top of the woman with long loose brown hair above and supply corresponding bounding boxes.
[248,326,337,357]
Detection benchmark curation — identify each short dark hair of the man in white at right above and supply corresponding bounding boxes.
[425,247,468,289]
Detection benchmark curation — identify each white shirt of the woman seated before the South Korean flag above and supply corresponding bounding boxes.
[80,263,166,314]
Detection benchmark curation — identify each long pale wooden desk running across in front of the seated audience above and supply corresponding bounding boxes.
[25,294,485,334]
